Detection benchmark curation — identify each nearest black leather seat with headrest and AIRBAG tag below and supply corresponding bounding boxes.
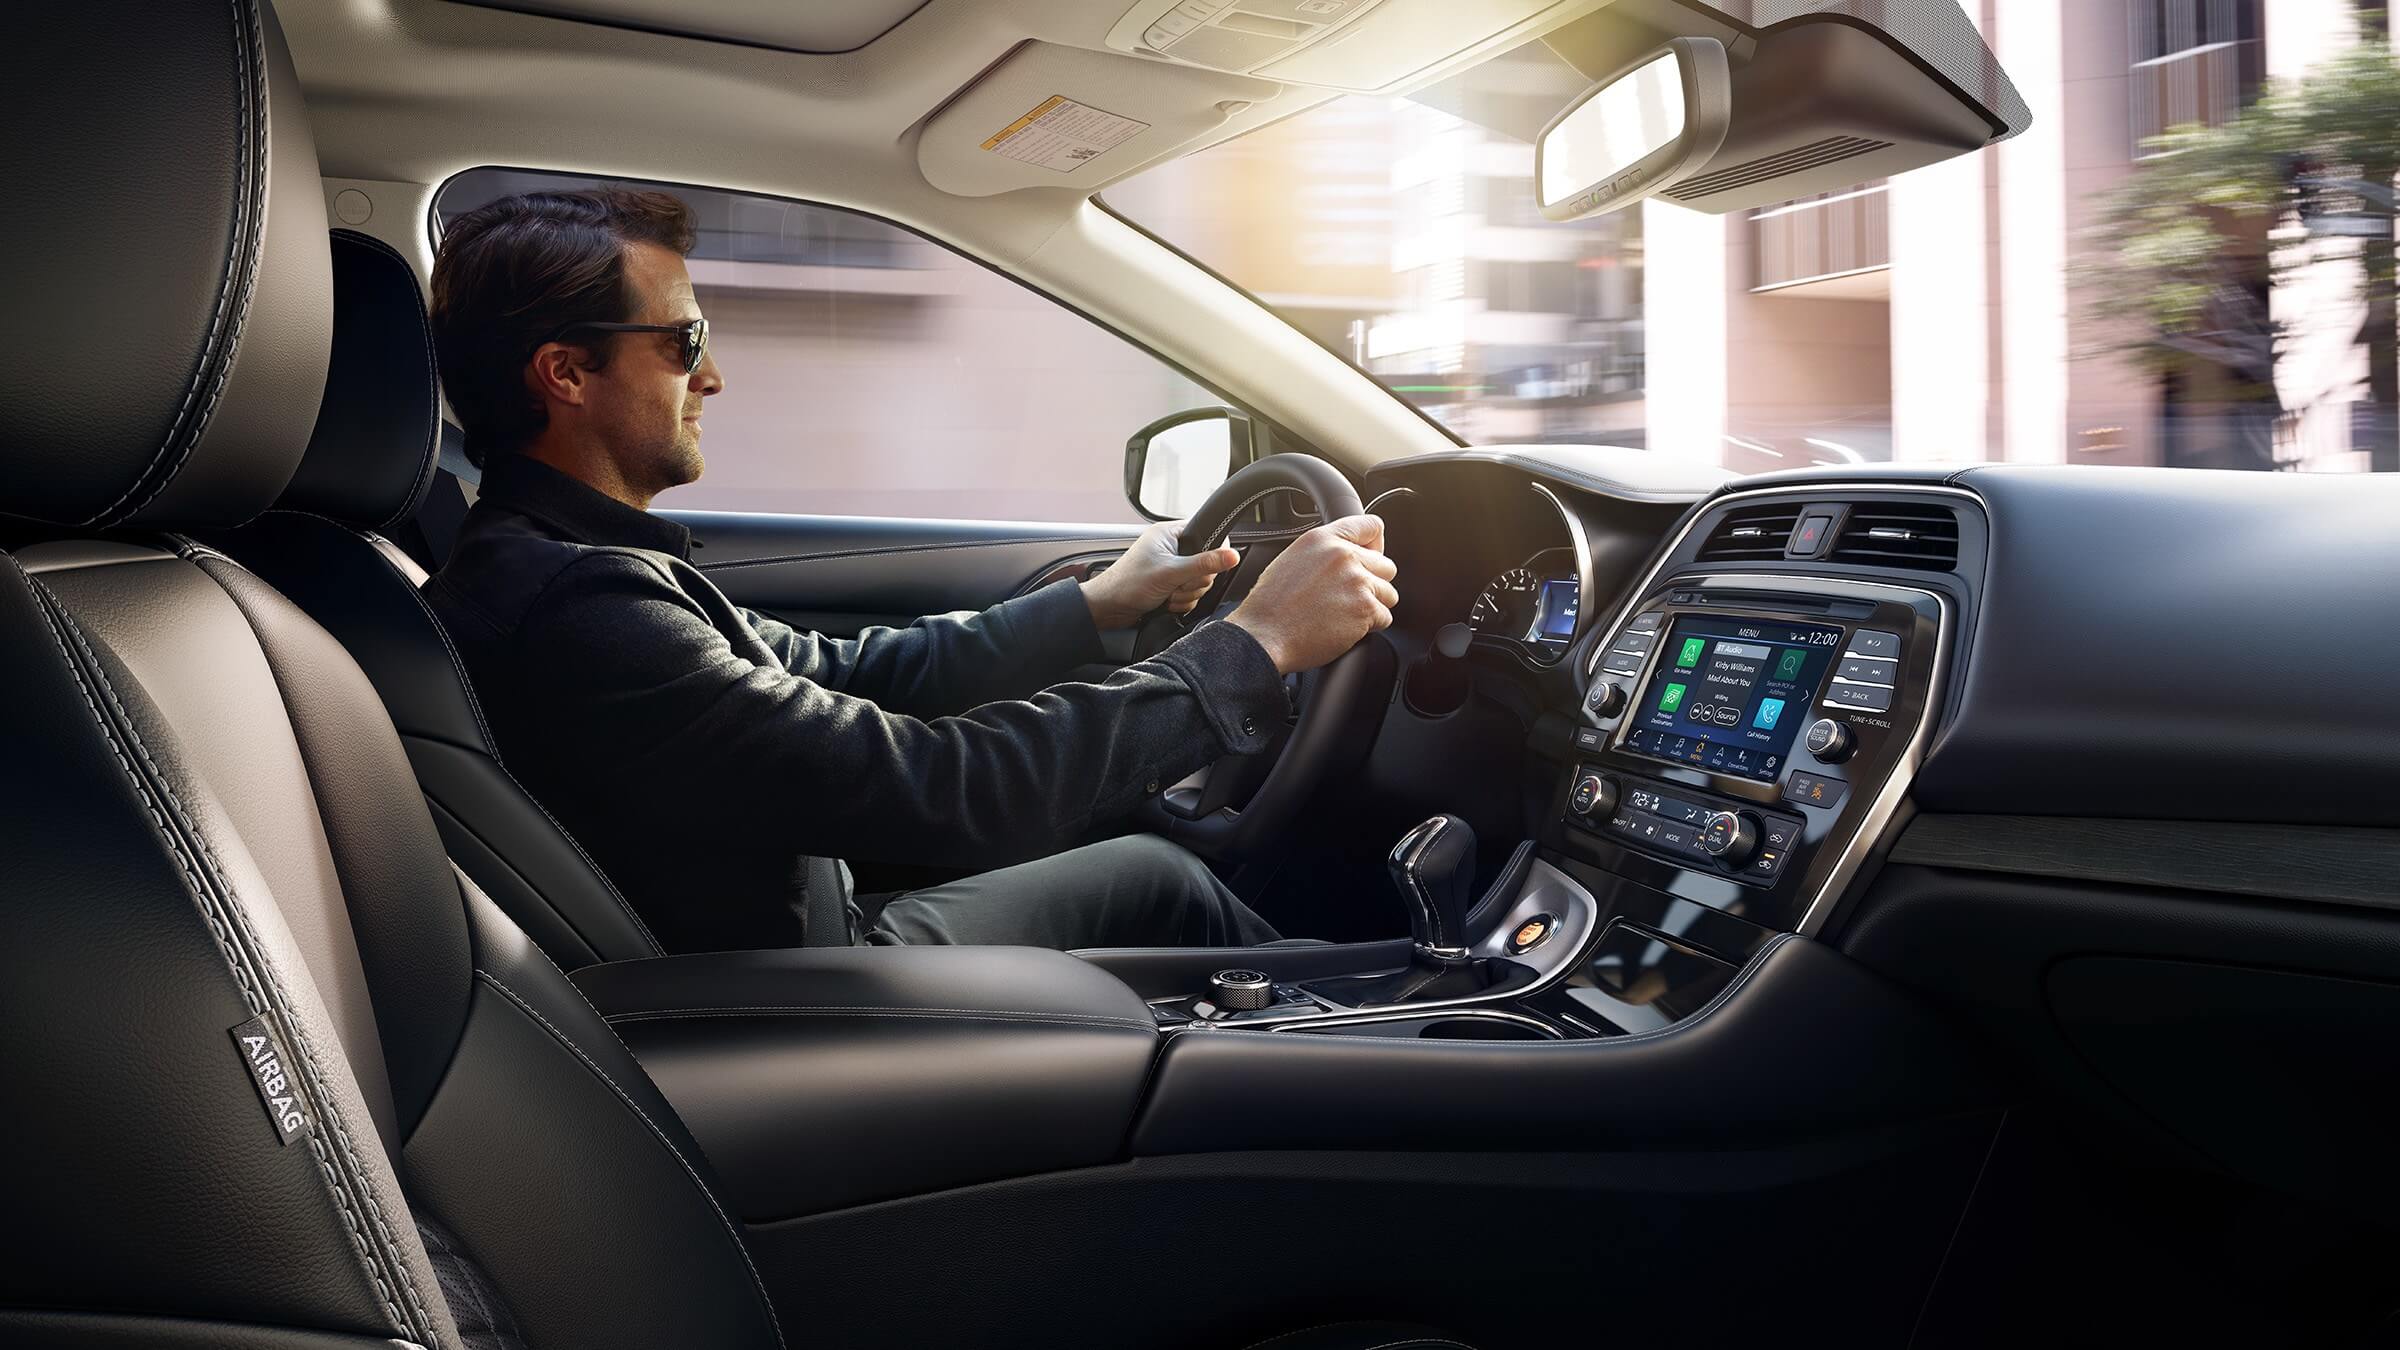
[0,0,1438,1350]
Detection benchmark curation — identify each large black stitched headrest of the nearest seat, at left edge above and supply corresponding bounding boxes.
[0,0,334,528]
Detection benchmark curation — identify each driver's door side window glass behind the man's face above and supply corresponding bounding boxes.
[434,168,1219,524]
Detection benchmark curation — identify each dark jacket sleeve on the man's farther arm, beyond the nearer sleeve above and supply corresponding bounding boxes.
[742,571,1102,718]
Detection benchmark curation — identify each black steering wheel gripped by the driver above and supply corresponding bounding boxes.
[1133,454,1392,860]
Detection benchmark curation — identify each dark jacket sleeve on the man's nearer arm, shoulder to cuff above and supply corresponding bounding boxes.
[516,552,1286,867]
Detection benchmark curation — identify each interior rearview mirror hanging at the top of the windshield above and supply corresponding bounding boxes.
[1534,38,1733,221]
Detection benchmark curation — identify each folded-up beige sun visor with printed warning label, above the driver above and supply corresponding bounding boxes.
[917,43,1282,197]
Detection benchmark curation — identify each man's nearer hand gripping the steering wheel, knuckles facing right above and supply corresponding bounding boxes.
[1226,516,1399,675]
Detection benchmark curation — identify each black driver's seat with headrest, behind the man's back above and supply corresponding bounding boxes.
[199,231,660,970]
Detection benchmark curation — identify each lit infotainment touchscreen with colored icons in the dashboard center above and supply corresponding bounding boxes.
[1625,615,1841,783]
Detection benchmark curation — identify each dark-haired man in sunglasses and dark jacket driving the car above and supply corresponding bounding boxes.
[425,190,1399,951]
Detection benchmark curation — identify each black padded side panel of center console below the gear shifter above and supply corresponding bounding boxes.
[1133,934,1997,1143]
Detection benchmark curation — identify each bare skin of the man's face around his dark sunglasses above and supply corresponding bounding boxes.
[586,243,725,492]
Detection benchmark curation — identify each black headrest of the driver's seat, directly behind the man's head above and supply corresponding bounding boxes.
[276,231,442,531]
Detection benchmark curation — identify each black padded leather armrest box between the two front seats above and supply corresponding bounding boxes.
[574,946,1159,1223]
